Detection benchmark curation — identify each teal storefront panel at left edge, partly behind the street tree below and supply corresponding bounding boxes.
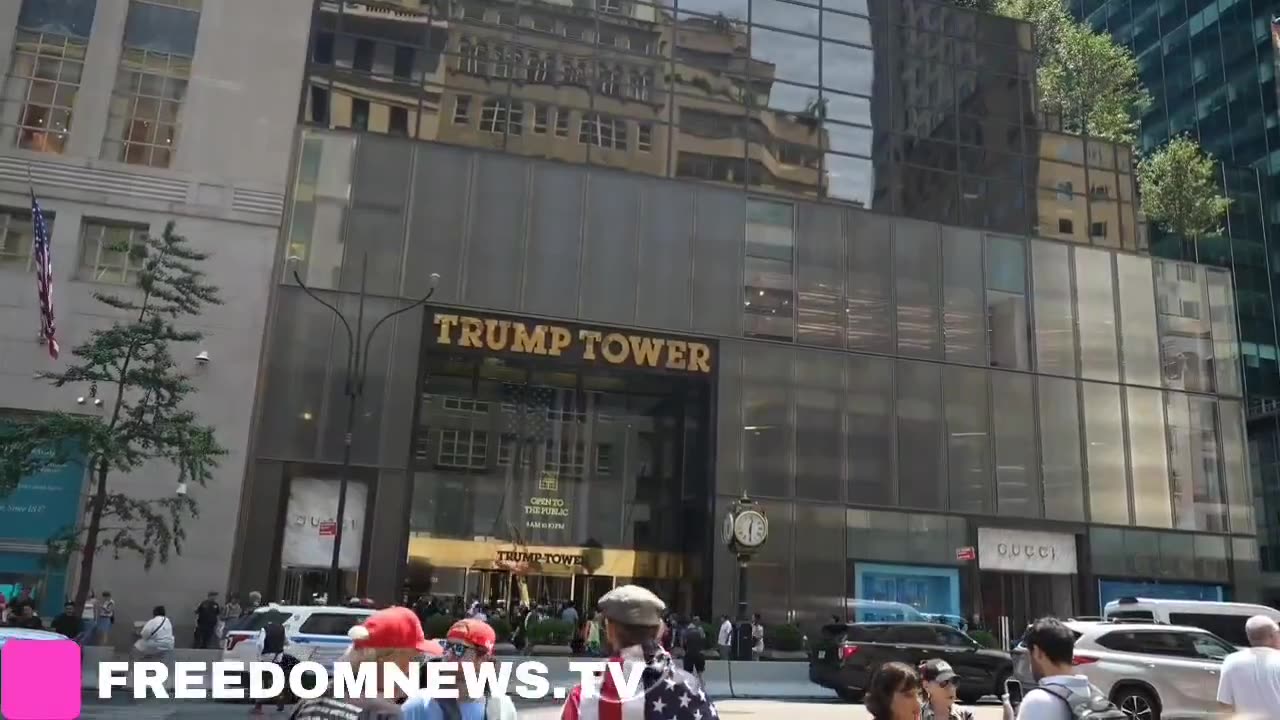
[0,440,84,618]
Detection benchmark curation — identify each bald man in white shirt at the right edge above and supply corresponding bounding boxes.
[1217,607,1280,717]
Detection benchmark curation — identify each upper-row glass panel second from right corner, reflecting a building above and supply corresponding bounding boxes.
[1155,260,1213,392]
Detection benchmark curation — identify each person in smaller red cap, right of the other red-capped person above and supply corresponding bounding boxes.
[401,618,516,720]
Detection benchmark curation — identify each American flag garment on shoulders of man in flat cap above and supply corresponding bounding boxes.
[561,646,719,720]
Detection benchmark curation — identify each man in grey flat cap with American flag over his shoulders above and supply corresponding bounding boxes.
[561,585,718,720]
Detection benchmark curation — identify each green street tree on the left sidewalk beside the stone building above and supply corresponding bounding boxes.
[0,222,225,607]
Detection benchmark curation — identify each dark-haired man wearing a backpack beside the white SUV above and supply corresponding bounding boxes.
[1004,618,1128,720]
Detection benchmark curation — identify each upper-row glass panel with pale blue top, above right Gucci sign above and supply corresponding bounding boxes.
[987,236,1030,369]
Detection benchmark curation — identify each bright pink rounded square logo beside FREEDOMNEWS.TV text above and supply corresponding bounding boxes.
[0,641,81,720]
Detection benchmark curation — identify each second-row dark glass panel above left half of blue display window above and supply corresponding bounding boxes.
[846,355,896,505]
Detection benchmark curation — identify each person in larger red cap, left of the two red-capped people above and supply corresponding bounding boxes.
[292,607,443,720]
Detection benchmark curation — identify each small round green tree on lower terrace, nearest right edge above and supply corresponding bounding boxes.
[1138,136,1231,241]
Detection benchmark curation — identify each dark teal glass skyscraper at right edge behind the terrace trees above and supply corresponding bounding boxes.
[1085,0,1280,601]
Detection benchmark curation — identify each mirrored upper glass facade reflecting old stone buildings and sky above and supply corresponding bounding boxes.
[301,0,1146,245]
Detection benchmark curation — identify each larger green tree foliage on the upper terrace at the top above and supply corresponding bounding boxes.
[996,0,1151,145]
